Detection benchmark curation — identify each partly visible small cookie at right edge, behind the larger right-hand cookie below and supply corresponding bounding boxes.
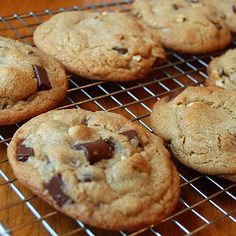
[206,49,236,91]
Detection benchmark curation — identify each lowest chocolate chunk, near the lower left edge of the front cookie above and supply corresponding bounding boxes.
[44,174,73,207]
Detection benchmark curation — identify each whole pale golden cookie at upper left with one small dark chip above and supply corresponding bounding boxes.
[34,11,166,81]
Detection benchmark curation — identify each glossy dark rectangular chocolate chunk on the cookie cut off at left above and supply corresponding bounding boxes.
[33,65,52,91]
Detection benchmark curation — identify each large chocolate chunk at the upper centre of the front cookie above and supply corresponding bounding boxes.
[73,140,114,165]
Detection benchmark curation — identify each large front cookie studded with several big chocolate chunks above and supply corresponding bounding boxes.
[8,109,180,230]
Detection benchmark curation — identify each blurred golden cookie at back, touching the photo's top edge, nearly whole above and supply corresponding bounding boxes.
[132,0,231,54]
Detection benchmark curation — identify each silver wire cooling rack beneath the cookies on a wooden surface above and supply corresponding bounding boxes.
[0,0,236,236]
